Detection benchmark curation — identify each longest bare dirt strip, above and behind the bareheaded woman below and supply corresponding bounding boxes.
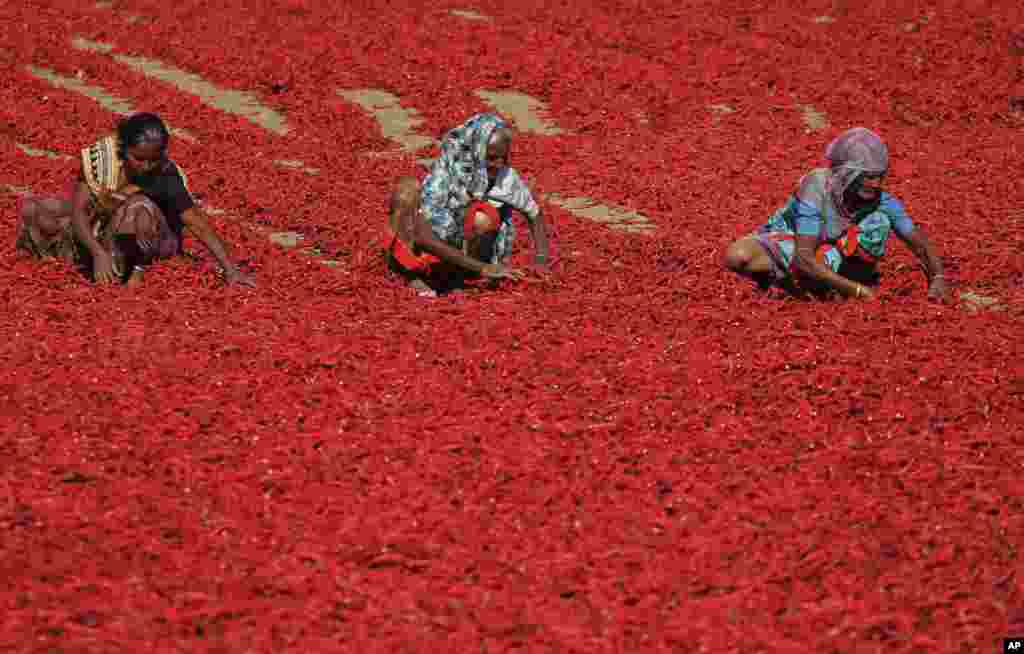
[72,38,289,135]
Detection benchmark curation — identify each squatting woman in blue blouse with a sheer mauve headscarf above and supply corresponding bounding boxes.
[724,127,947,300]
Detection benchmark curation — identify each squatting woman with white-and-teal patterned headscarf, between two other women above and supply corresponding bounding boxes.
[387,114,548,297]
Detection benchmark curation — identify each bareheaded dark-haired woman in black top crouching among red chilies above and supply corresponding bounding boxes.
[16,114,254,286]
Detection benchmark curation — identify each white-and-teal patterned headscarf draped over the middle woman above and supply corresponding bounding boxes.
[421,114,506,239]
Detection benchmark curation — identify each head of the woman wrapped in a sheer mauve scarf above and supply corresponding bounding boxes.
[825,127,889,208]
